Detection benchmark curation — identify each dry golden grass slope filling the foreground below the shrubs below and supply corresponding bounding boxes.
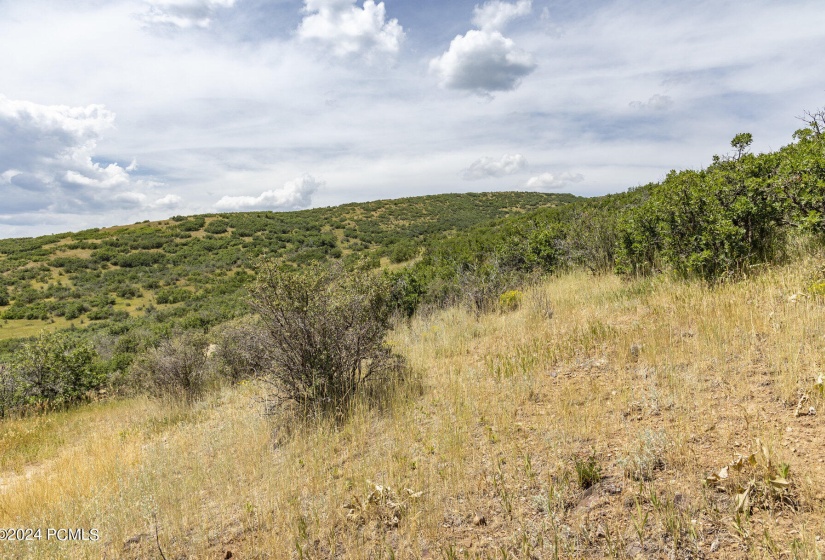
[0,257,825,560]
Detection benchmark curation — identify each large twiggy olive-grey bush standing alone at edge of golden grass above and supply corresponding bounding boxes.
[250,263,403,414]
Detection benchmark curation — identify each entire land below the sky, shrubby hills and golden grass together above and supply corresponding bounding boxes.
[0,113,825,560]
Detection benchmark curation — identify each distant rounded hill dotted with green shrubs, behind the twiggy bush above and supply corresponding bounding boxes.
[0,192,576,346]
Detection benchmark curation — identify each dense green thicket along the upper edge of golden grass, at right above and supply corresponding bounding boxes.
[392,113,825,312]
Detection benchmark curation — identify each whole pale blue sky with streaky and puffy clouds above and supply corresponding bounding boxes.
[0,0,825,238]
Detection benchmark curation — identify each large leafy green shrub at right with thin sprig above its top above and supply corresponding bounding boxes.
[618,134,787,280]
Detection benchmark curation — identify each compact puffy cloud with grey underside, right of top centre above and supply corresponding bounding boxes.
[430,29,536,94]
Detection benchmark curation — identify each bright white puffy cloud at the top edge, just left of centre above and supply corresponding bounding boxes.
[298,0,404,57]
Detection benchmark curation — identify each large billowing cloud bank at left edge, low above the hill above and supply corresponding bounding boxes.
[0,96,152,212]
